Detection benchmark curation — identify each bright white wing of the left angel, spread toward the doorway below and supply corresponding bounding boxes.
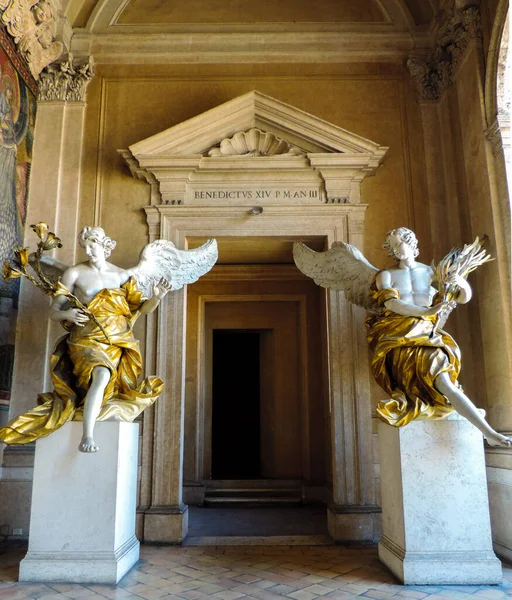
[127,240,218,298]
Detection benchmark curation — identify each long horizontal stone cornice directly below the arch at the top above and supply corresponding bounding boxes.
[71,28,420,64]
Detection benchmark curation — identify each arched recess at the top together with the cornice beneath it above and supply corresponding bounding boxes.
[61,0,444,63]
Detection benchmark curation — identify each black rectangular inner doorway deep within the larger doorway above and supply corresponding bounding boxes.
[212,329,261,479]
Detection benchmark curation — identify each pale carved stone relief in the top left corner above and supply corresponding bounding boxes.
[0,0,63,79]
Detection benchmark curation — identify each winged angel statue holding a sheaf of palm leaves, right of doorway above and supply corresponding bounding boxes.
[294,227,512,447]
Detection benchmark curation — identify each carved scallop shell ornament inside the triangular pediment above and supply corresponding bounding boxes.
[208,129,303,156]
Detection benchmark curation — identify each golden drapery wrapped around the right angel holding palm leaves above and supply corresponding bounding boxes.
[366,284,460,427]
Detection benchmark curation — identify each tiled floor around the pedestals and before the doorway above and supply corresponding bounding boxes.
[0,544,512,600]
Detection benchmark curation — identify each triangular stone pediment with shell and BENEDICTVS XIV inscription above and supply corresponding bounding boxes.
[119,90,387,206]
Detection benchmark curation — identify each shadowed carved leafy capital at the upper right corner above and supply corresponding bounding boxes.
[407,7,482,100]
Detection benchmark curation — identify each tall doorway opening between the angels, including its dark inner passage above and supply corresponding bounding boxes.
[183,265,330,506]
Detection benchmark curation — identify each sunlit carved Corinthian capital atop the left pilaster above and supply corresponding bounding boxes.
[38,54,94,102]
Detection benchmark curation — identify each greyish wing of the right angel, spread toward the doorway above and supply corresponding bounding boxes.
[293,242,379,310]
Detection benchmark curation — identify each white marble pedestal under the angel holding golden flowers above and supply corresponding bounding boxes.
[19,422,139,584]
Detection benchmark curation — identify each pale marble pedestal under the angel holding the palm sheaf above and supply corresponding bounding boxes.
[379,414,502,585]
